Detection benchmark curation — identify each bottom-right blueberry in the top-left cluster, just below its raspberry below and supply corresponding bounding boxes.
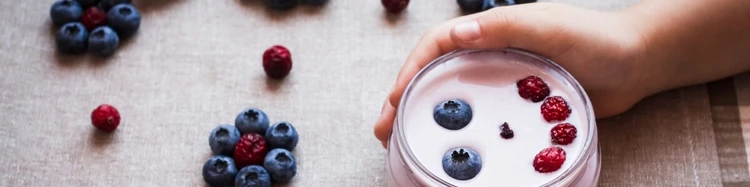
[88,26,120,57]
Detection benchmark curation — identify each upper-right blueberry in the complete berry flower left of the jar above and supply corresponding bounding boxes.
[265,121,299,151]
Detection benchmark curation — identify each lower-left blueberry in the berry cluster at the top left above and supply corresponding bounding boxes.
[55,22,89,53]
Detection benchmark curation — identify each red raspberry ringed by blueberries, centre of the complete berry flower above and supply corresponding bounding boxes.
[234,133,268,168]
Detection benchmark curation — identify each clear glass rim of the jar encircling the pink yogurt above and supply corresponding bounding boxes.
[391,48,598,187]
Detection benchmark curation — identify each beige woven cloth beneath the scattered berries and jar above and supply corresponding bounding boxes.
[0,0,750,187]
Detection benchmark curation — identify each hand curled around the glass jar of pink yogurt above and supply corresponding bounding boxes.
[375,3,646,146]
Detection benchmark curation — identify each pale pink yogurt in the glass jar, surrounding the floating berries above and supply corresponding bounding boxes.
[387,49,600,187]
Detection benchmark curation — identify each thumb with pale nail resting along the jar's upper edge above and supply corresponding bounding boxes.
[451,5,564,50]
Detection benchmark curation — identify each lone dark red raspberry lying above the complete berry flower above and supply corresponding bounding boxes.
[263,45,292,79]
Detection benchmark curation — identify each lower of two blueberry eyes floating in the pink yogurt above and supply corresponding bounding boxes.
[443,148,482,180]
